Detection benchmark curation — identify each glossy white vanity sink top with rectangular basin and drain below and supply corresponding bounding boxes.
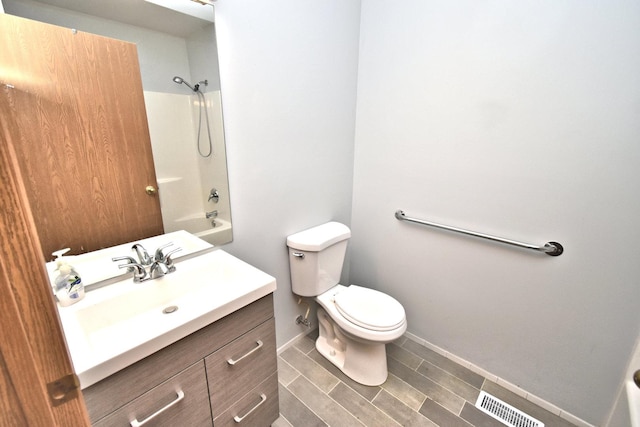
[58,249,276,388]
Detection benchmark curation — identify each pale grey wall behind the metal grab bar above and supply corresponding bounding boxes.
[350,0,640,425]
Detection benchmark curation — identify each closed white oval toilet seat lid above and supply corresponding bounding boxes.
[333,285,405,331]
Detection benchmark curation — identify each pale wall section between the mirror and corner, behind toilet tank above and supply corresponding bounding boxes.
[215,0,360,345]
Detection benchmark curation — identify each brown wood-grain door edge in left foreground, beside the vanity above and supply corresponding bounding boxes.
[0,77,89,427]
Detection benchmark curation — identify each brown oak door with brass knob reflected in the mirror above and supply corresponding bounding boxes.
[0,15,163,259]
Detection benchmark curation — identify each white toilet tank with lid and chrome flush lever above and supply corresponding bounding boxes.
[287,222,351,297]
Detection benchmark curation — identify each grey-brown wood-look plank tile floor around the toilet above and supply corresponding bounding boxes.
[273,331,573,427]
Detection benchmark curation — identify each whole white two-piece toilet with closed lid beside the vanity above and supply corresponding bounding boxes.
[287,222,407,386]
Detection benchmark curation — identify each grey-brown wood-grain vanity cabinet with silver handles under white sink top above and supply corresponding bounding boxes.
[83,294,279,427]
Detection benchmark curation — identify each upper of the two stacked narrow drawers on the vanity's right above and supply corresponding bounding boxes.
[205,318,277,418]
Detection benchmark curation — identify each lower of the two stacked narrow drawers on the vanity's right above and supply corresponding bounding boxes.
[214,373,280,427]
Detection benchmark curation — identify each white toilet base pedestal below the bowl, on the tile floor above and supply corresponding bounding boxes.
[316,308,388,386]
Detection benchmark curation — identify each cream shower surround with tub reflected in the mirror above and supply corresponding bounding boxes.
[144,91,231,245]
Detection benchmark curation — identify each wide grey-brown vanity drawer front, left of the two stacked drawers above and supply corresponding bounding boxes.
[94,361,212,427]
